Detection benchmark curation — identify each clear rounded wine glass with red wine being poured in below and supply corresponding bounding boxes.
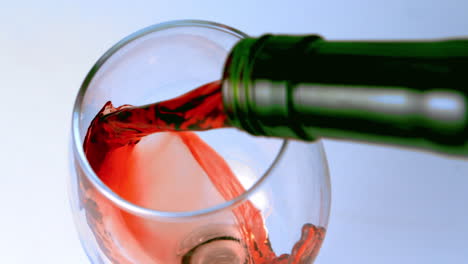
[69,20,330,264]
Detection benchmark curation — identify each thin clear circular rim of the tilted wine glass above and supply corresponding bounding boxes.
[72,20,288,221]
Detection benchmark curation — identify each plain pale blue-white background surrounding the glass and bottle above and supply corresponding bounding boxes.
[0,0,468,264]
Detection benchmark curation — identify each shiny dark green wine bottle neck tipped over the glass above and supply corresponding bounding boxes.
[222,35,468,156]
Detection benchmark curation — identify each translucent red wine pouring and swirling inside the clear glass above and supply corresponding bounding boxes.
[84,82,325,264]
